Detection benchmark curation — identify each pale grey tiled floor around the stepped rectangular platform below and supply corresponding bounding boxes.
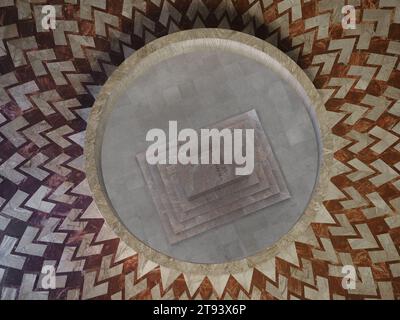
[102,50,321,263]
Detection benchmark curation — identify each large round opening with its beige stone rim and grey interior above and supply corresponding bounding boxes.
[85,29,333,274]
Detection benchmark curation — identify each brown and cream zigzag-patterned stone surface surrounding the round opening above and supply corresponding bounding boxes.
[0,0,400,299]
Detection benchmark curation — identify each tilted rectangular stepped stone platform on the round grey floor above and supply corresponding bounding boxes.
[136,110,290,244]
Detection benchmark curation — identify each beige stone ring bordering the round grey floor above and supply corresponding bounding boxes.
[84,28,334,276]
